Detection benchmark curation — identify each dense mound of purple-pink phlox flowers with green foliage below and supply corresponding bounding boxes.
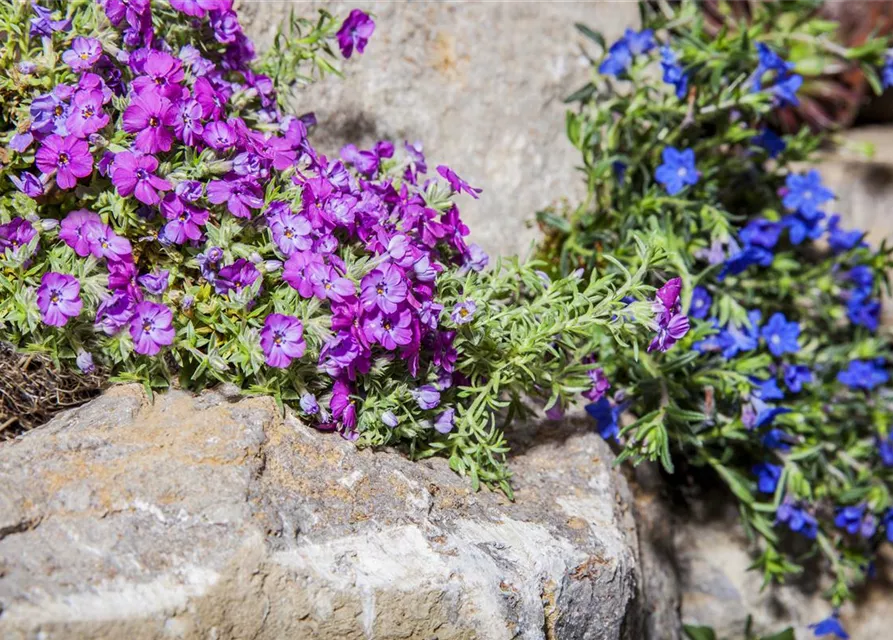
[0,0,665,494]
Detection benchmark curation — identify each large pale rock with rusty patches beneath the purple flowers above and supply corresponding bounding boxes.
[0,386,678,640]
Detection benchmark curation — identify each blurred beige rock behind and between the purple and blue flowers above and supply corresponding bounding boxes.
[240,0,639,255]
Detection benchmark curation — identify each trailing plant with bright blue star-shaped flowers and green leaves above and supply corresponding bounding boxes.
[538,0,893,637]
